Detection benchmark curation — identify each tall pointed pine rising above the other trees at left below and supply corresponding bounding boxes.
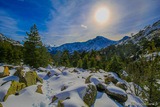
[24,24,50,68]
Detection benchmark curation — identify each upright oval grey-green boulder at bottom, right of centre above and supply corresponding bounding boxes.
[83,84,97,107]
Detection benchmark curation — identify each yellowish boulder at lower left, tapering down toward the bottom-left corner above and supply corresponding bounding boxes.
[4,81,26,101]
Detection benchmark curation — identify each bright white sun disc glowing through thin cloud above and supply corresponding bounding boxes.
[95,7,109,24]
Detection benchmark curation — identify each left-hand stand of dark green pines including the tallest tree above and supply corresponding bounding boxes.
[0,24,52,68]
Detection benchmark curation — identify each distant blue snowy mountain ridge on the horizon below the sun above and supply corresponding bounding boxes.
[48,36,129,53]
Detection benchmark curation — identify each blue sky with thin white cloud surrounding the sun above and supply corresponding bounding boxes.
[0,0,160,45]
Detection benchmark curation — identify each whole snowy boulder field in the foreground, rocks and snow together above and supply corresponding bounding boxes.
[0,66,145,107]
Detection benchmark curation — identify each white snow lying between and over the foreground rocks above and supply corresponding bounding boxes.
[0,66,144,107]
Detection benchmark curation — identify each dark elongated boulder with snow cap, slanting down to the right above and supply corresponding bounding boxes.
[105,86,128,104]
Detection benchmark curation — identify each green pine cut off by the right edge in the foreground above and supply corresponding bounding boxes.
[144,56,160,106]
